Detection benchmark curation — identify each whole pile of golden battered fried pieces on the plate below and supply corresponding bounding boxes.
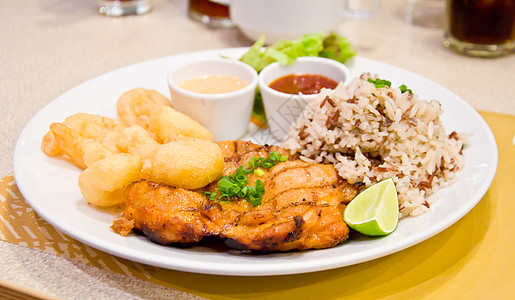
[41,88,224,206]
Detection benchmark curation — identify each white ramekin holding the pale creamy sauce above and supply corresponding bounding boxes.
[168,58,258,141]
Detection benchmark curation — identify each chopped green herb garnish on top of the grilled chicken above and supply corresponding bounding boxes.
[204,151,288,207]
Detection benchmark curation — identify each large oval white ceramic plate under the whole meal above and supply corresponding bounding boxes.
[14,48,497,275]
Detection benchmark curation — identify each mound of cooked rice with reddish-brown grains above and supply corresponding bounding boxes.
[283,74,464,216]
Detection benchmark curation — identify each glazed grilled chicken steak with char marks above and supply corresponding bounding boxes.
[113,141,357,251]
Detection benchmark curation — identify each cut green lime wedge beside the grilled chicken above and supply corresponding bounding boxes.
[343,178,399,236]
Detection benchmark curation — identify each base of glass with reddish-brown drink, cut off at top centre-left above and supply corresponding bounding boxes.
[188,0,234,28]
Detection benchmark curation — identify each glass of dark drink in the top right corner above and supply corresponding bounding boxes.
[444,0,515,57]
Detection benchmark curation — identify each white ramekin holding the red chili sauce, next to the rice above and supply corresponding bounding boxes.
[259,57,350,140]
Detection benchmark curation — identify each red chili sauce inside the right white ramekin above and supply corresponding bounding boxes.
[269,74,338,95]
